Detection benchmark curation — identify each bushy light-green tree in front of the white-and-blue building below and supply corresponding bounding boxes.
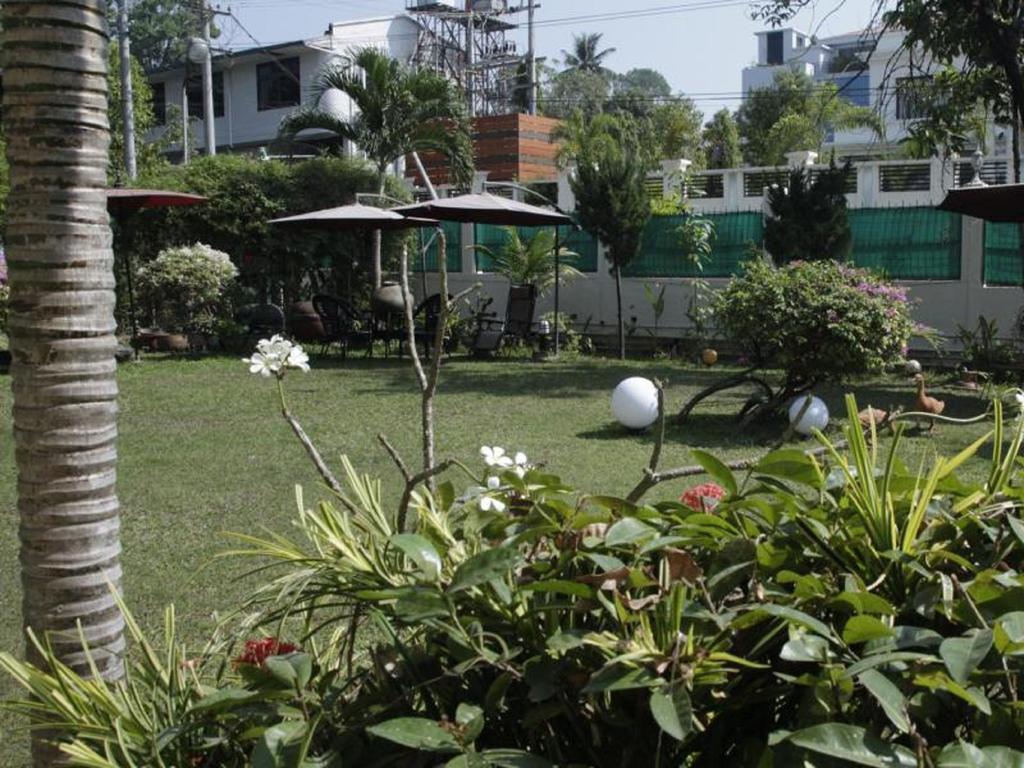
[736,70,882,165]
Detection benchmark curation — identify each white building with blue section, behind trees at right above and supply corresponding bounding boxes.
[742,28,1008,157]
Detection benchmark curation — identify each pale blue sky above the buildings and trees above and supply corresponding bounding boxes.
[218,0,874,119]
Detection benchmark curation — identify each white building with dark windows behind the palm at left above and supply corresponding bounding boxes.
[150,14,419,154]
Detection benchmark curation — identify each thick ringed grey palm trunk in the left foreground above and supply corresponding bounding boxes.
[2,0,124,765]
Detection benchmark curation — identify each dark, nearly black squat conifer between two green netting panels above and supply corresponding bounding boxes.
[765,163,853,264]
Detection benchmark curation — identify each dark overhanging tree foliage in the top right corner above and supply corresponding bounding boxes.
[755,0,1024,179]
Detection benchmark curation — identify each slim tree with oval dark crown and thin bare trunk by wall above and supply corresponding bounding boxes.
[571,119,650,359]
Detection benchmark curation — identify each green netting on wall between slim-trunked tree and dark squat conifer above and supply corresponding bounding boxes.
[623,212,763,278]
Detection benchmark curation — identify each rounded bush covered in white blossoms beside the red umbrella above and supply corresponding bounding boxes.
[138,243,239,333]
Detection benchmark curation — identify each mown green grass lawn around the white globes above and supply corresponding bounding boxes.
[0,357,999,765]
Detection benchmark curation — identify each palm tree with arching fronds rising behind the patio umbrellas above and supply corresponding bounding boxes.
[280,48,473,288]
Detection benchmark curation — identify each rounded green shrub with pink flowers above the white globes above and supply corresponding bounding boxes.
[715,261,915,389]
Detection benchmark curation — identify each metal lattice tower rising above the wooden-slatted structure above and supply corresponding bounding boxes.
[406,0,523,116]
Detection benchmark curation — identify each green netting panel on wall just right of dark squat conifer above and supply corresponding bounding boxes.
[849,208,961,280]
